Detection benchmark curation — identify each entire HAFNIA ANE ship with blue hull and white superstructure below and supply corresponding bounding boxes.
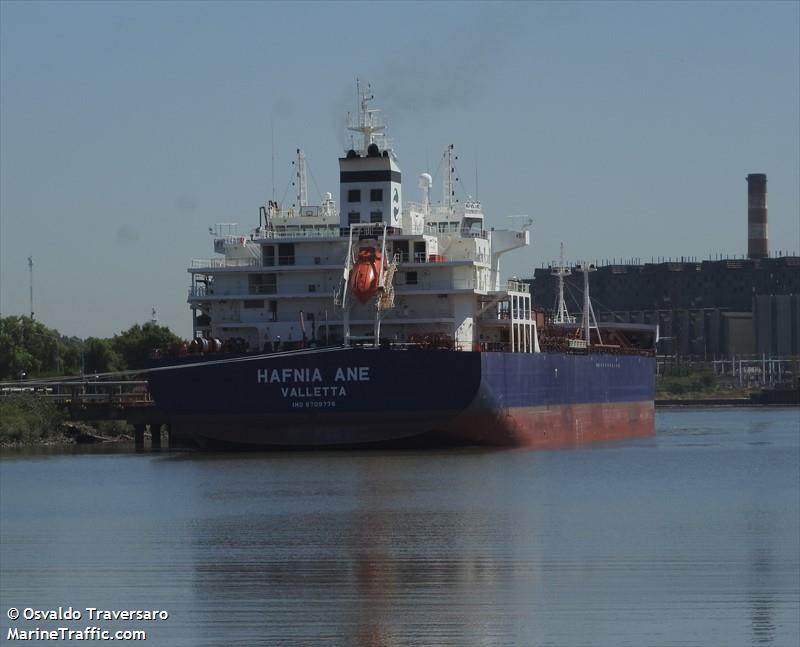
[148,86,657,448]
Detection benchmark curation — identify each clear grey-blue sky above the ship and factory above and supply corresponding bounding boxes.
[0,0,800,337]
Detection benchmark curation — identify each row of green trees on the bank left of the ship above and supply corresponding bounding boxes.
[0,316,183,381]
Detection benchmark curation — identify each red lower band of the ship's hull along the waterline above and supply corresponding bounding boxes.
[171,401,655,449]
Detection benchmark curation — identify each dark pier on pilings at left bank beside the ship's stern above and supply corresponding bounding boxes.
[0,376,182,449]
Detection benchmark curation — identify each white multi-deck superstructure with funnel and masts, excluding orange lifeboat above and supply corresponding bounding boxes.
[189,85,538,352]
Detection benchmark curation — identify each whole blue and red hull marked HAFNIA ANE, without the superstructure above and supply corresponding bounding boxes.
[148,348,655,447]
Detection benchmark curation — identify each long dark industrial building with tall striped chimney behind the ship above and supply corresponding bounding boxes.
[528,173,800,359]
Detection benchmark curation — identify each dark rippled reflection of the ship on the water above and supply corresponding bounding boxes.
[187,451,516,647]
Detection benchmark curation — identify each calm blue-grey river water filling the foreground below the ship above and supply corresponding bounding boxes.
[0,409,800,647]
